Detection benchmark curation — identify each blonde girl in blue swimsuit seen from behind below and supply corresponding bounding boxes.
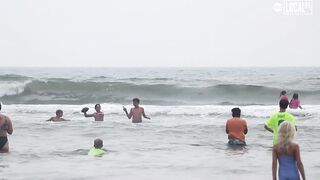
[272,122,306,180]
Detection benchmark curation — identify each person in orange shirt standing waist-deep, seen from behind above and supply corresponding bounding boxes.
[226,108,248,145]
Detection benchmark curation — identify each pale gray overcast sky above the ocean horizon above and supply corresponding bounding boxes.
[0,0,320,66]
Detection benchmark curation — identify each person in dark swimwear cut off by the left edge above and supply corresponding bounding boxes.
[0,104,13,153]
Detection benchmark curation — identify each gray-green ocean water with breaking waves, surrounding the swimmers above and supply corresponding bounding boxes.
[0,67,320,180]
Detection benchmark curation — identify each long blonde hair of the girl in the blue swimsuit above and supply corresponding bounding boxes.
[278,121,296,151]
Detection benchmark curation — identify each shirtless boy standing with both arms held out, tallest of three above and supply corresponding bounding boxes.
[123,98,151,123]
